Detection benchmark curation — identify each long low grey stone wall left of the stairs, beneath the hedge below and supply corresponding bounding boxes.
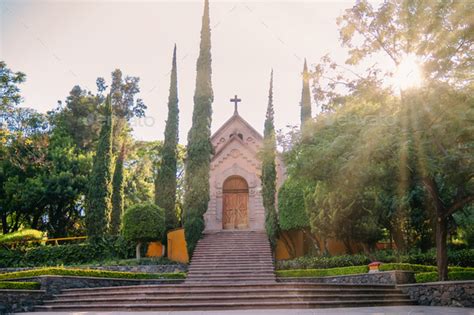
[5,275,184,296]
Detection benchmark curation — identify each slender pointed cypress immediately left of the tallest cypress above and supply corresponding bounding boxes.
[155,45,179,230]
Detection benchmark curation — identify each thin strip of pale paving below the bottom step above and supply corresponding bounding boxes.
[18,306,474,315]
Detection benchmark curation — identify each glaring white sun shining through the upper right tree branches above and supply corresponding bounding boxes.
[393,54,422,90]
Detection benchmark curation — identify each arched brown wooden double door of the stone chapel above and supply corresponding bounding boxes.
[222,176,249,229]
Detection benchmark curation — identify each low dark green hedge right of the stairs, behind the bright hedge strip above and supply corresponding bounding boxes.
[277,255,371,269]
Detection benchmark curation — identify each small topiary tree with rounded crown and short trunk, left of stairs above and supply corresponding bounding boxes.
[122,202,165,259]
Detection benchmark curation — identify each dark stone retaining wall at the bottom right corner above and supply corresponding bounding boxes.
[398,280,474,307]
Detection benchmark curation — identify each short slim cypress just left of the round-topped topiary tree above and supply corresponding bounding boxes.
[110,142,125,235]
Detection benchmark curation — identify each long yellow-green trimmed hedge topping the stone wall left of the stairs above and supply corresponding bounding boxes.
[0,268,186,280]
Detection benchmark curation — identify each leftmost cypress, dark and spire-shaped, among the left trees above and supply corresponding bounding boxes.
[85,95,113,241]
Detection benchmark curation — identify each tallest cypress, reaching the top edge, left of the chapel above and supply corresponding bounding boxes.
[183,0,214,255]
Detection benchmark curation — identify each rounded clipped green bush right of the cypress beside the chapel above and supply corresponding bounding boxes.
[278,178,309,230]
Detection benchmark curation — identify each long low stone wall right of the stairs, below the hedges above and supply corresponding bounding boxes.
[278,270,415,284]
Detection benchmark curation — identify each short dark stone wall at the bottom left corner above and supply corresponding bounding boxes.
[0,289,46,313]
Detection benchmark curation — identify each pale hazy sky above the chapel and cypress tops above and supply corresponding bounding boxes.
[0,0,360,144]
